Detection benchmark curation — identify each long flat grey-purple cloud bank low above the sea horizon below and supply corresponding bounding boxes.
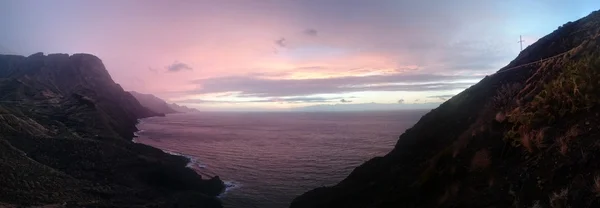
[188,74,482,97]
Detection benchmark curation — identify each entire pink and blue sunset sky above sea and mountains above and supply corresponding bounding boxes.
[0,0,600,110]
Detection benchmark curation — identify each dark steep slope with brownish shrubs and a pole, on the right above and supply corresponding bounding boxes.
[291,11,600,208]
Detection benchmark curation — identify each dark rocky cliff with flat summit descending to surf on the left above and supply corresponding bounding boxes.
[0,53,224,207]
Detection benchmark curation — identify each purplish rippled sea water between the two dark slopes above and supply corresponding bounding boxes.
[136,111,426,208]
